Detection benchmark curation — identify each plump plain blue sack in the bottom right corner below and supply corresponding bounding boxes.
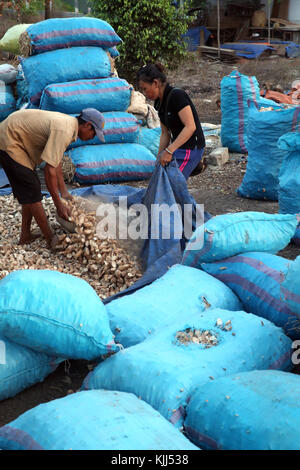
[184,370,300,451]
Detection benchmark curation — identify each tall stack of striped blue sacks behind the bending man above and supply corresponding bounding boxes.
[18,17,155,184]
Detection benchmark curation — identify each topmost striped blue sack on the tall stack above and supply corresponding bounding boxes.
[26,17,121,55]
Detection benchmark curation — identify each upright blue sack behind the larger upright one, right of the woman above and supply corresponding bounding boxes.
[237,102,300,201]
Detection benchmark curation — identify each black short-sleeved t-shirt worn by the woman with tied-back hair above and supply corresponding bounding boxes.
[154,83,205,149]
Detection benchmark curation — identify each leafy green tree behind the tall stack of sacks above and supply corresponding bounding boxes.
[90,0,191,80]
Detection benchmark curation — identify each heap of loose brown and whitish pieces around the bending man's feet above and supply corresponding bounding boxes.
[0,195,142,299]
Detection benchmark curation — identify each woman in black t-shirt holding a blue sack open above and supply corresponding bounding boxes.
[137,64,205,179]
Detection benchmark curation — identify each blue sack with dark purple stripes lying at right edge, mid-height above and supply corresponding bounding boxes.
[201,252,300,339]
